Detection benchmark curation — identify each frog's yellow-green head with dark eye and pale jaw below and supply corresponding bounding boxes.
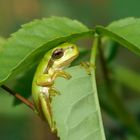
[51,43,79,68]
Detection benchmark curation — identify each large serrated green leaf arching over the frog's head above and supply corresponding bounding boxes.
[0,17,91,84]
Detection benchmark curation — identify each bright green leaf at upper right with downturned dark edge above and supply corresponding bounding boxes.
[96,17,140,55]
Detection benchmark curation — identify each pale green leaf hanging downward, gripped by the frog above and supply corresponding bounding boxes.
[52,66,105,140]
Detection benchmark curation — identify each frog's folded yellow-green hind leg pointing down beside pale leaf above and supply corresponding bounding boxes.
[39,93,56,132]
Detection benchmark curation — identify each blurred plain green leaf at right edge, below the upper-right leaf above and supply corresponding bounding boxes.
[115,66,140,93]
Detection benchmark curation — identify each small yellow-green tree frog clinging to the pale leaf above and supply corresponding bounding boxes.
[32,43,79,131]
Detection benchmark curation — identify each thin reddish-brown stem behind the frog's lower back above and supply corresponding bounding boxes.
[1,85,34,111]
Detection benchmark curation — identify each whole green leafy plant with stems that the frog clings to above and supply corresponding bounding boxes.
[0,17,140,140]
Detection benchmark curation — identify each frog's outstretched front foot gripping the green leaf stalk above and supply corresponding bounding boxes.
[80,62,96,75]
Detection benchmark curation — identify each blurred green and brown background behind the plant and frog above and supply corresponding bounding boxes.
[0,0,140,140]
